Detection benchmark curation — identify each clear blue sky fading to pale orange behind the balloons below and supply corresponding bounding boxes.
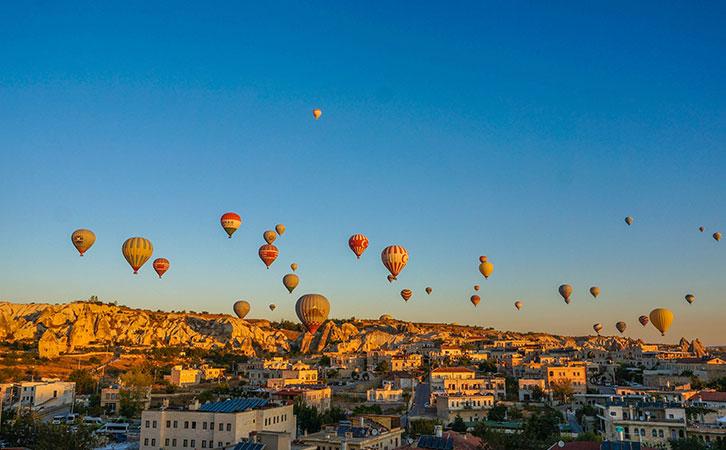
[0,1,726,344]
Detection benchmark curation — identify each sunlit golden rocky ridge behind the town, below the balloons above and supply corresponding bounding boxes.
[0,301,700,358]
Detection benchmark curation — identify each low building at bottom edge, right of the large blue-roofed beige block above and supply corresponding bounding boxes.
[298,418,403,450]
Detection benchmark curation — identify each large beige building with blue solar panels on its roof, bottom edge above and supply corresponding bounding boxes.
[140,398,296,450]
